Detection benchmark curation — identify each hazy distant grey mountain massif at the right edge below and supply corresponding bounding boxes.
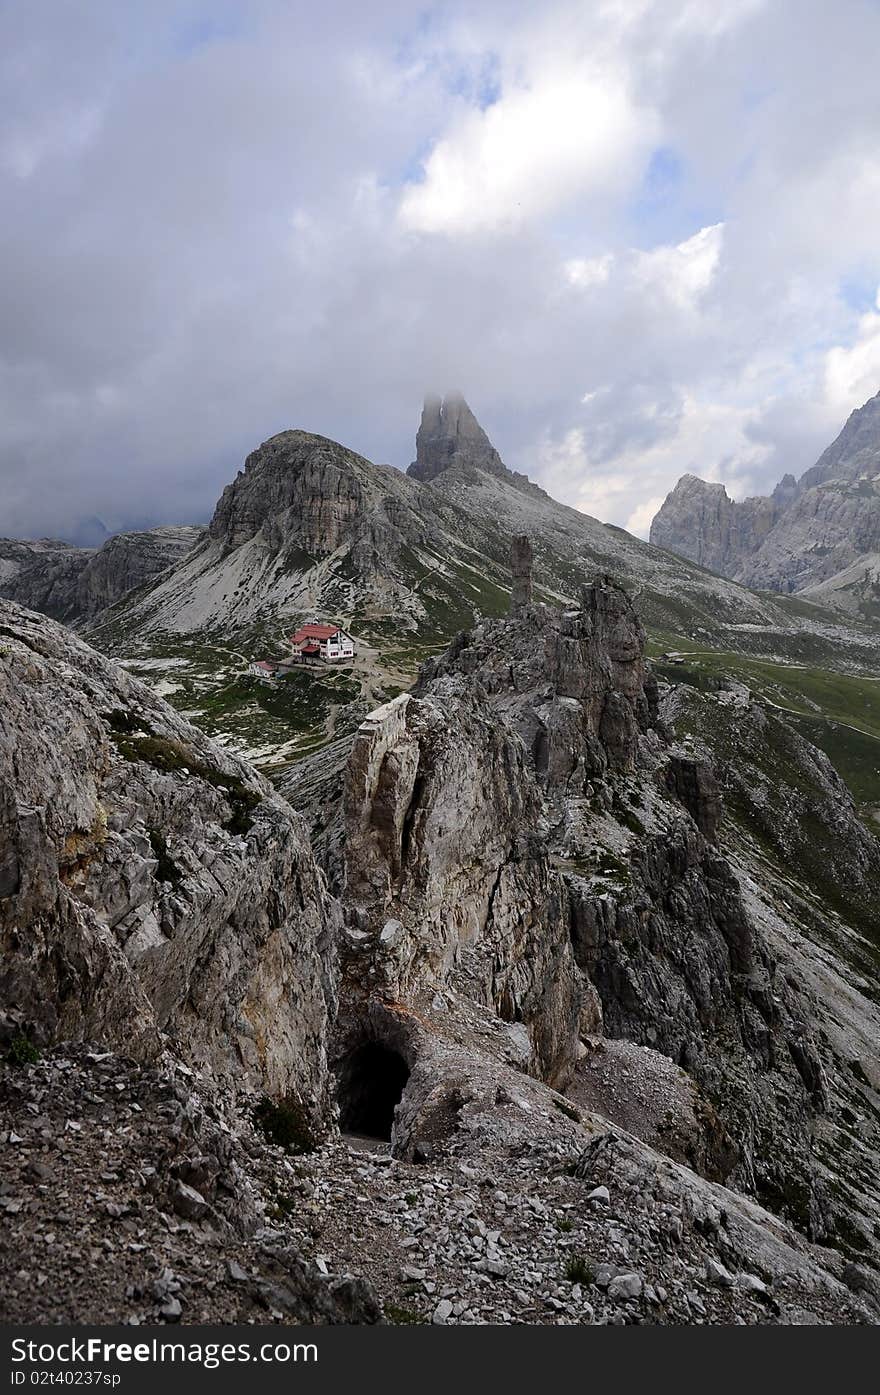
[651,393,880,600]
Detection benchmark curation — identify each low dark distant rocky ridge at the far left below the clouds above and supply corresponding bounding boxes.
[0,527,202,622]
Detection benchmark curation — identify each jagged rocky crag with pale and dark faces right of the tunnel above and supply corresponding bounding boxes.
[323,566,853,1235]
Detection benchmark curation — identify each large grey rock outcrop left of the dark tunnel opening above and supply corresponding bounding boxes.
[0,603,336,1131]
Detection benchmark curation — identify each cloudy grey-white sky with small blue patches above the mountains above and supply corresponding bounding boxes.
[0,0,880,536]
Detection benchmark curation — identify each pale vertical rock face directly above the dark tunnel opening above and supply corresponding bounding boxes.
[346,682,582,1081]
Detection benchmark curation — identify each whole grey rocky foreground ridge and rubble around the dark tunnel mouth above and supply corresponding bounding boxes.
[0,580,880,1325]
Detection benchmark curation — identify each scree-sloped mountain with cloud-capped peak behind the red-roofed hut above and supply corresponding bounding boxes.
[92,398,875,647]
